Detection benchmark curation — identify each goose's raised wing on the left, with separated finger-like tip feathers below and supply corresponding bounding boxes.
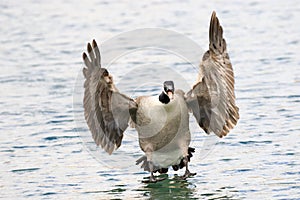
[83,40,137,154]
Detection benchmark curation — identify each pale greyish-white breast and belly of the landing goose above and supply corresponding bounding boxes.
[136,95,190,167]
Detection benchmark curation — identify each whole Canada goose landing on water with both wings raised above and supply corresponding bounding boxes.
[83,12,239,182]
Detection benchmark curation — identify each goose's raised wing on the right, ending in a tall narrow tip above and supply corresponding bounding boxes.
[187,12,239,137]
